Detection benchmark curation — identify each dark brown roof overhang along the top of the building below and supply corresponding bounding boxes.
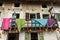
[0,0,60,2]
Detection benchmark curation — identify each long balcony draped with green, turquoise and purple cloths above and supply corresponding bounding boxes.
[1,19,58,33]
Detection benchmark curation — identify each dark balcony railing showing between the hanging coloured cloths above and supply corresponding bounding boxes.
[3,20,58,31]
